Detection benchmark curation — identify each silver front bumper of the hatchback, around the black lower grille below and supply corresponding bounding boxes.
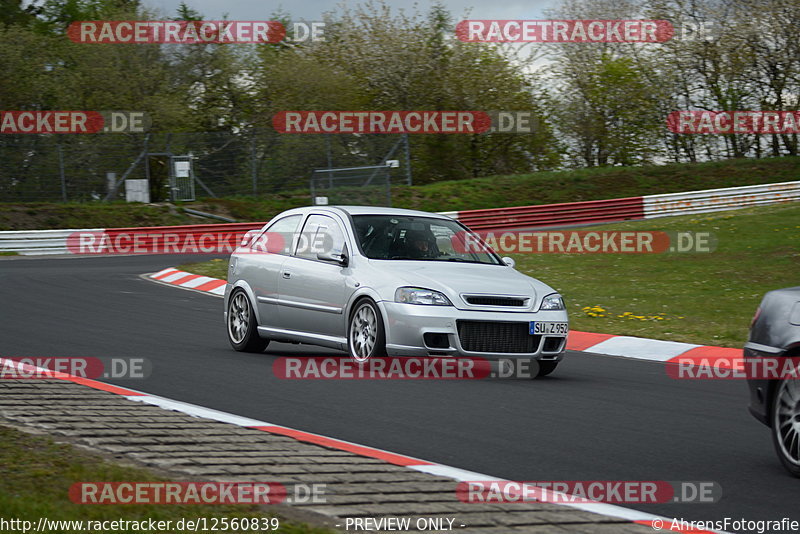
[378,301,568,361]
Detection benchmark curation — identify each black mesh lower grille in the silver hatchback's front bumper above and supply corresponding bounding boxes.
[456,321,542,354]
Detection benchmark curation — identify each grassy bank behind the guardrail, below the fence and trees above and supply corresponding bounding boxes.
[0,157,800,230]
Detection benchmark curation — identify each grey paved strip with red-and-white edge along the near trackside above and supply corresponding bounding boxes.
[0,358,711,534]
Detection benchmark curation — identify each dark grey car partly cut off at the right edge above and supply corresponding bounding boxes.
[744,286,800,477]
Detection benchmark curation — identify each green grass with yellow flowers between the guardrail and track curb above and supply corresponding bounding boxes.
[180,202,800,347]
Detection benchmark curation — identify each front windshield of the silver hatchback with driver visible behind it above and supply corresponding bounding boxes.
[353,215,502,265]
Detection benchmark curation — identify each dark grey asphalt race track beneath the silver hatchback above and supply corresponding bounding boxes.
[0,256,800,532]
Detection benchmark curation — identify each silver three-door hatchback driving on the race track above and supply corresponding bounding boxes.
[225,206,569,376]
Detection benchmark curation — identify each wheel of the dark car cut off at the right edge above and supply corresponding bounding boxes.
[770,380,800,477]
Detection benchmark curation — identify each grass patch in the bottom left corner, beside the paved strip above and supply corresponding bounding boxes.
[0,426,331,534]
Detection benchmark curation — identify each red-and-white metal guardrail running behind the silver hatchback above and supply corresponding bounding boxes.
[0,181,800,255]
